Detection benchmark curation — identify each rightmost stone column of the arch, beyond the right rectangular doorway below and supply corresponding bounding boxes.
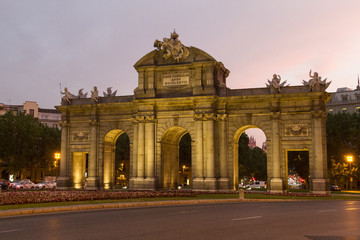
[310,111,329,194]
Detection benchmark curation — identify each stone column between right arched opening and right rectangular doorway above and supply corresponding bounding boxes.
[270,112,283,193]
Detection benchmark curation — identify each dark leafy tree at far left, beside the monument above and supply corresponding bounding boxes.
[0,112,60,176]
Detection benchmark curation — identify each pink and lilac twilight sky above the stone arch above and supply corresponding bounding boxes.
[0,0,360,144]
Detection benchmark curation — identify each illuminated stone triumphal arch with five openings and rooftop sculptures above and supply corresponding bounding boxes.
[57,31,330,193]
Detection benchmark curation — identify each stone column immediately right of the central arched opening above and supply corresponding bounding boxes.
[192,114,204,189]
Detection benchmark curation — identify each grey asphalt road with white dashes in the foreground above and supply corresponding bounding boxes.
[0,201,360,240]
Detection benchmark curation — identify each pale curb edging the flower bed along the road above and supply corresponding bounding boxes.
[0,199,250,217]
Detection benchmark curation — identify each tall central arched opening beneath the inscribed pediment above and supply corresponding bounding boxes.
[161,127,192,189]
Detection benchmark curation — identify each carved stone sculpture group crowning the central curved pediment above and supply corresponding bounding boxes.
[154,30,189,63]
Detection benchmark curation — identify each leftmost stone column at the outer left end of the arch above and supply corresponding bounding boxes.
[56,121,70,189]
